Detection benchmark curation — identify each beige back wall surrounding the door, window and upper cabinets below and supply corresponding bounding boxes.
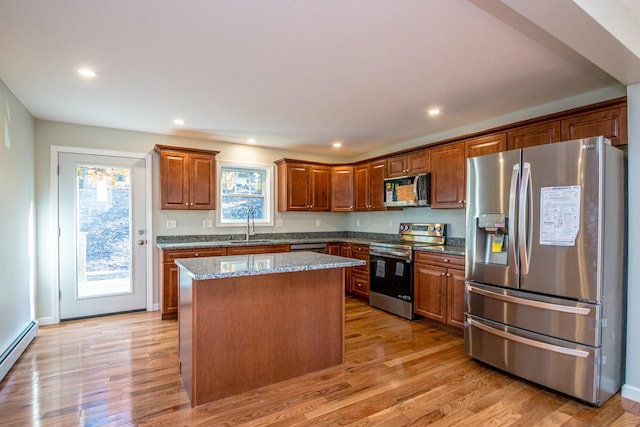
[35,120,356,323]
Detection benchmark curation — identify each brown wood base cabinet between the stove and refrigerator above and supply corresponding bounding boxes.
[413,251,464,328]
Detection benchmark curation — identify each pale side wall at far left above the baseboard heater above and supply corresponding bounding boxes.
[0,81,35,354]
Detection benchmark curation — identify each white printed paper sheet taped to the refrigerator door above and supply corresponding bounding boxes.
[540,185,580,246]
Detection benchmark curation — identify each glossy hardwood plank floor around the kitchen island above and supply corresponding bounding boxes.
[0,298,640,426]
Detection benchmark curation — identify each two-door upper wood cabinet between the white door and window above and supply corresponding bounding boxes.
[154,145,218,210]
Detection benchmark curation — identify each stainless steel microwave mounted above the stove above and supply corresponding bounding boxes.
[384,173,431,207]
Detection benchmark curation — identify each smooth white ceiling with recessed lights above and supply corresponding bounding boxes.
[0,0,640,157]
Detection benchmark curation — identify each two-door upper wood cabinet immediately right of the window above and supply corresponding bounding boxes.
[276,159,331,211]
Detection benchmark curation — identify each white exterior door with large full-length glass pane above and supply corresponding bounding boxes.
[58,153,147,320]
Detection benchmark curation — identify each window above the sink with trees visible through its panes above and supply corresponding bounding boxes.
[219,164,271,224]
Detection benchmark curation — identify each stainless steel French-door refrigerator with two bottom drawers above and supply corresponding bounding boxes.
[464,137,624,405]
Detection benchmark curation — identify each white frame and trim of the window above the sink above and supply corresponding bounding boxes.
[216,160,275,227]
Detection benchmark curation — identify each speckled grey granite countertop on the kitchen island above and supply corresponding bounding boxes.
[175,252,366,280]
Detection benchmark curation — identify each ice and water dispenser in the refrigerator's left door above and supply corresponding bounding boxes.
[475,213,509,266]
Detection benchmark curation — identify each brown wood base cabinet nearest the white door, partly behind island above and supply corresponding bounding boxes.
[160,248,227,320]
